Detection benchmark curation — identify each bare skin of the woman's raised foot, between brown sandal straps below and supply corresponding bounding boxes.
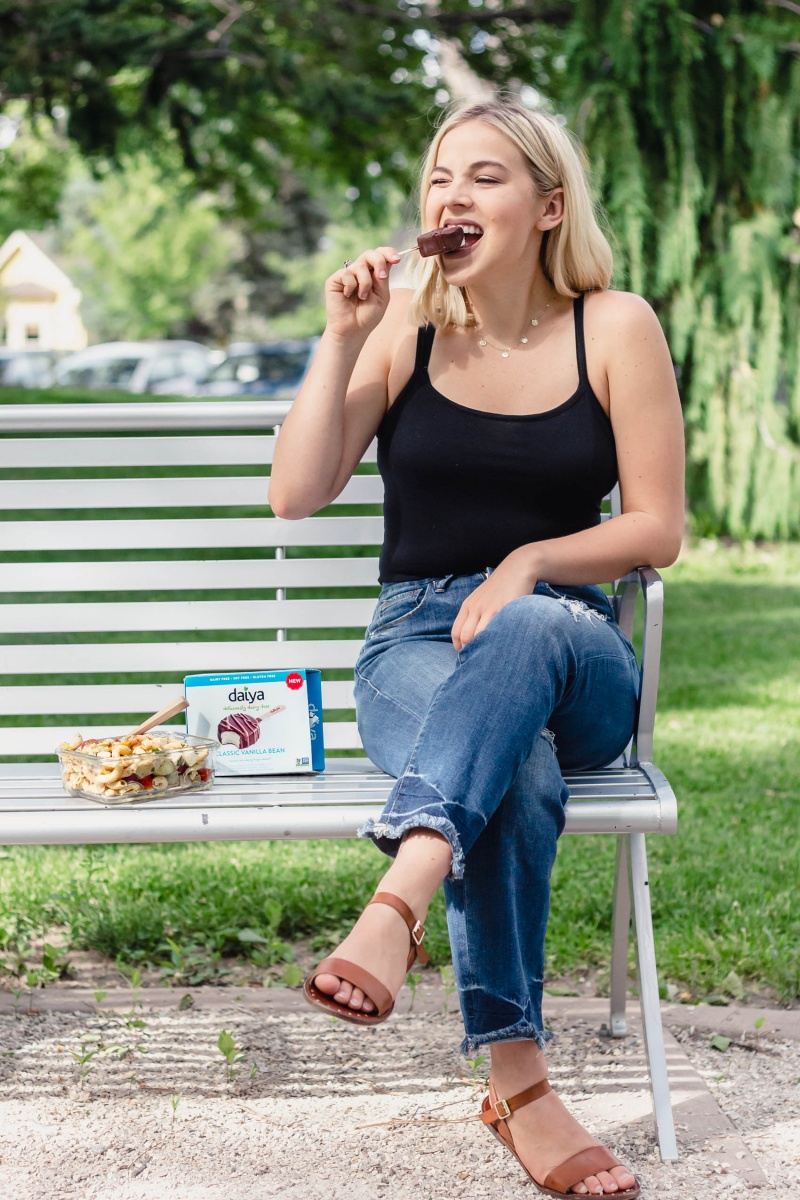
[314,904,410,1013]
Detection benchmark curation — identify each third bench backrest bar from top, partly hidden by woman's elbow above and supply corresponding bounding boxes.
[0,475,384,511]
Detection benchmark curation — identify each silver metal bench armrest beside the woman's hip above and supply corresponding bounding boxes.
[616,566,664,766]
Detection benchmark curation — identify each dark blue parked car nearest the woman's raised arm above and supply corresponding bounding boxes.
[197,337,319,396]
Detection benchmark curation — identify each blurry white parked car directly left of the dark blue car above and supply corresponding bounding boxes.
[54,341,213,396]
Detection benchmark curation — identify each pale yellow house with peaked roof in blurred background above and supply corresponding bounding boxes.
[0,229,88,350]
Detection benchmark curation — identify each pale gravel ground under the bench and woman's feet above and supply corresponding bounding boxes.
[0,989,800,1200]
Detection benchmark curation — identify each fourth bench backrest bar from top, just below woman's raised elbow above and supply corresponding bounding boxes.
[0,517,384,552]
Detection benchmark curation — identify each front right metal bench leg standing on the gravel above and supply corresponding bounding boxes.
[630,833,678,1163]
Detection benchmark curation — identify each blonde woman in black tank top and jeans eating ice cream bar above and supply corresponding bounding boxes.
[270,101,682,1198]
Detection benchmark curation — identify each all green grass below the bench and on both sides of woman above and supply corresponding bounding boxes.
[0,542,800,1000]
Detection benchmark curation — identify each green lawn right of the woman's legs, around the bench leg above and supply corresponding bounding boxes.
[549,542,800,1000]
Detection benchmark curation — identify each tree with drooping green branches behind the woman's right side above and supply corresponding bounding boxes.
[537,0,800,538]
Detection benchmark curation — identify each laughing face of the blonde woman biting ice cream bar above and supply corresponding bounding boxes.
[425,121,561,286]
